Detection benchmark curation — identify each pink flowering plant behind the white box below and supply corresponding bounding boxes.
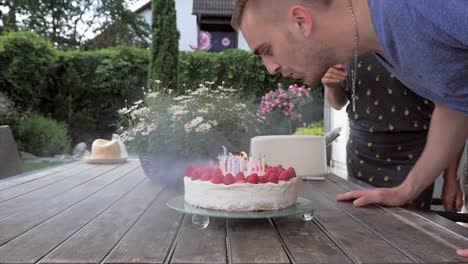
[257,83,313,134]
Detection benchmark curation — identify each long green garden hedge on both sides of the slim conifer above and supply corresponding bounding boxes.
[0,32,323,143]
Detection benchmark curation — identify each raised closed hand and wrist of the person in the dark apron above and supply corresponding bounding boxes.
[322,64,348,110]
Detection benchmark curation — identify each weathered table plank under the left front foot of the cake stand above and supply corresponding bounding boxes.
[170,215,227,264]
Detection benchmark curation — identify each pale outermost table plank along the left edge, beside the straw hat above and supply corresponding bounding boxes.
[0,164,96,203]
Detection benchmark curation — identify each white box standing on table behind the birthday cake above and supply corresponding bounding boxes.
[250,135,328,178]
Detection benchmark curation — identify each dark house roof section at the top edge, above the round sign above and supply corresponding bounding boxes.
[192,0,234,16]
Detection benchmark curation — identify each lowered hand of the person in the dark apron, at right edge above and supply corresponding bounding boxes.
[441,174,463,212]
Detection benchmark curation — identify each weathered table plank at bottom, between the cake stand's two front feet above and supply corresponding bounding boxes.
[228,219,290,264]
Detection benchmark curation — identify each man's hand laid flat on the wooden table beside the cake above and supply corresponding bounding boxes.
[336,186,412,206]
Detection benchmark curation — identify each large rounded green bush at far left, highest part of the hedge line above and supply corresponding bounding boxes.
[0,32,56,111]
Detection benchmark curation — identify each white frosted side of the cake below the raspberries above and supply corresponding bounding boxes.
[184,177,301,211]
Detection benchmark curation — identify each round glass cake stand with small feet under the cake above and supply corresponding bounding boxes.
[167,195,314,229]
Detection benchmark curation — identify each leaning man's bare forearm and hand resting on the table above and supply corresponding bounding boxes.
[336,104,468,206]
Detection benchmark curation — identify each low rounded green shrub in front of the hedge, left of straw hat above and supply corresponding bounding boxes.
[17,115,71,156]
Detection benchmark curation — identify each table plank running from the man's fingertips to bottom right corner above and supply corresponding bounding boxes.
[313,181,468,263]
